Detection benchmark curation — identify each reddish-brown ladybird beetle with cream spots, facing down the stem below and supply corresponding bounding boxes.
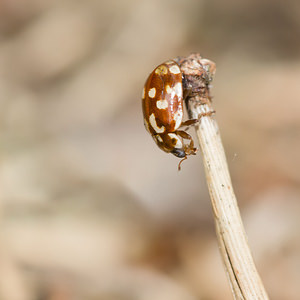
[142,60,198,170]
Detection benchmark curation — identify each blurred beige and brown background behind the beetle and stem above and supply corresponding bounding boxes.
[0,0,300,300]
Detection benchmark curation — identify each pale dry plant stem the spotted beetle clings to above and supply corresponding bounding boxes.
[180,54,268,300]
